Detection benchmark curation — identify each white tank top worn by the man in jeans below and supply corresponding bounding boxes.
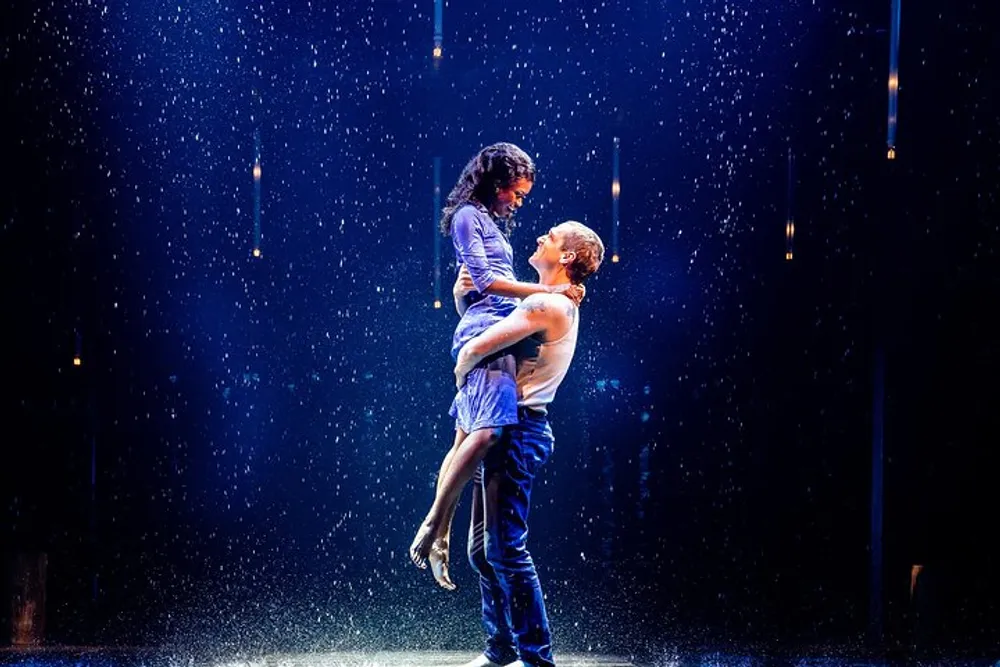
[516,306,580,413]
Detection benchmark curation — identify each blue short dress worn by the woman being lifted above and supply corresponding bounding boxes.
[448,204,518,433]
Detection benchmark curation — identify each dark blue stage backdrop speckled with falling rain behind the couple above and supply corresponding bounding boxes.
[0,0,1000,649]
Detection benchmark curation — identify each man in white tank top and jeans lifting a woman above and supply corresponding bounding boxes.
[450,221,604,667]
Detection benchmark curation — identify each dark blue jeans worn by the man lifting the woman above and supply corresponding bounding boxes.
[468,408,555,667]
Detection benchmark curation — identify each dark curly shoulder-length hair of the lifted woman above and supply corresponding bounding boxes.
[441,142,535,236]
